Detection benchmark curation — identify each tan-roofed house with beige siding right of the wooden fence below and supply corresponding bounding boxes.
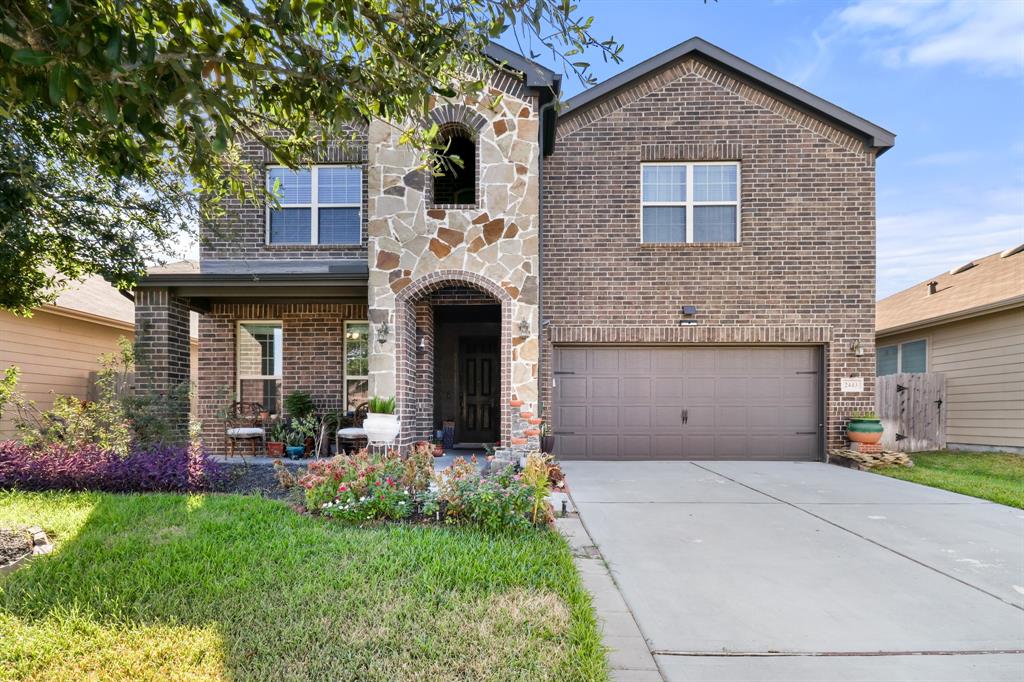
[874,245,1024,453]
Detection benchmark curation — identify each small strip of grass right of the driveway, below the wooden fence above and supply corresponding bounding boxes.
[874,451,1024,509]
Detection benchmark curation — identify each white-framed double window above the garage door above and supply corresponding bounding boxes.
[641,162,739,244]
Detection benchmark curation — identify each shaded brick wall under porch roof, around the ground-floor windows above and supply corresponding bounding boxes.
[198,302,367,446]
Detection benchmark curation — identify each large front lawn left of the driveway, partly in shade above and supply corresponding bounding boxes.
[0,492,606,681]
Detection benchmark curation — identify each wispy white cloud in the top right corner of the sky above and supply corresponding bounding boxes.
[838,0,1024,75]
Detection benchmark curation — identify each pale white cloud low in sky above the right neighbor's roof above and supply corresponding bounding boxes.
[878,204,1024,298]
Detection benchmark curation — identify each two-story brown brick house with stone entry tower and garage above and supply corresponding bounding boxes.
[136,38,894,460]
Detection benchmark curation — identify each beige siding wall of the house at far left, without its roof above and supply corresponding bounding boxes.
[0,311,199,437]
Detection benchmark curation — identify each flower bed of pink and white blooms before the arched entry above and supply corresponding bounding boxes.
[279,443,553,531]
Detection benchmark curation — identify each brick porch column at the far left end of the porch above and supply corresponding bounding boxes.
[135,289,190,441]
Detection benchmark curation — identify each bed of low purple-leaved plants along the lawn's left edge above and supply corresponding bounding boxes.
[0,440,221,493]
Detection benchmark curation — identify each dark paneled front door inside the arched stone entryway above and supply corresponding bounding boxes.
[456,336,501,442]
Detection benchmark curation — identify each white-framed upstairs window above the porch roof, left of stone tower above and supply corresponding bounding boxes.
[266,166,362,244]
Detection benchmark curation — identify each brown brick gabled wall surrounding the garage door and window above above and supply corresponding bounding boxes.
[542,58,874,447]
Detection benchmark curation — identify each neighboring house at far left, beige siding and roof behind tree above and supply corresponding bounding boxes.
[0,276,199,437]
